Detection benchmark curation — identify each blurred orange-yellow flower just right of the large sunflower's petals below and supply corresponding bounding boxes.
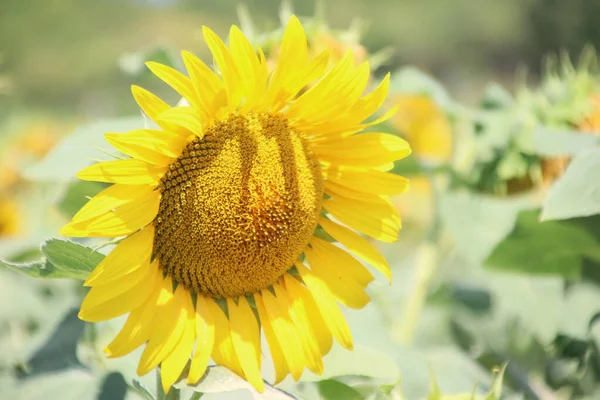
[392,95,452,162]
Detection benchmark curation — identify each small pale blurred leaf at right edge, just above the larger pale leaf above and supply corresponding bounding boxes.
[531,125,599,157]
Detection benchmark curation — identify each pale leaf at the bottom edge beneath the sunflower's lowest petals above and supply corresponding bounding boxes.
[173,365,295,400]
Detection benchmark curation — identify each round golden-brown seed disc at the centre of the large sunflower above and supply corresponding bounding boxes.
[154,113,323,298]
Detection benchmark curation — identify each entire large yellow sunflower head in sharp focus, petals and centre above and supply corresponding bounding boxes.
[61,17,410,391]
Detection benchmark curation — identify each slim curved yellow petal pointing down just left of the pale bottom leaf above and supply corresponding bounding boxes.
[160,293,196,393]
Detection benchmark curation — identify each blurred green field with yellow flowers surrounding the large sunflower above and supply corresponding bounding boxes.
[0,0,600,399]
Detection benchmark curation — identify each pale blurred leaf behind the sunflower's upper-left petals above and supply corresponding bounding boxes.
[24,116,144,182]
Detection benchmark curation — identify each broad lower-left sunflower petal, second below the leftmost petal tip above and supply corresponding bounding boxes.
[79,264,162,322]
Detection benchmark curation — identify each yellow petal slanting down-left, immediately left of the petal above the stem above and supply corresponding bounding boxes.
[137,285,190,376]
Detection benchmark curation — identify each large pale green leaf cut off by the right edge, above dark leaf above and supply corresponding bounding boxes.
[542,148,600,221]
